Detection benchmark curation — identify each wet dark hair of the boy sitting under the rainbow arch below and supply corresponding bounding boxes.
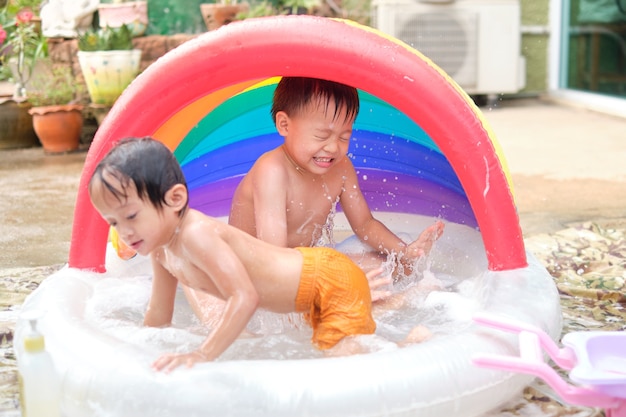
[272,77,359,122]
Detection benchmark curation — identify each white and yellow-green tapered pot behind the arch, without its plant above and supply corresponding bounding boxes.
[78,49,141,106]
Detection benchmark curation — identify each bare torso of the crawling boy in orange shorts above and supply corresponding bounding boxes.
[153,209,302,313]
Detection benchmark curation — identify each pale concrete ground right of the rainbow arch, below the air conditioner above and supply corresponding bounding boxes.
[483,95,626,236]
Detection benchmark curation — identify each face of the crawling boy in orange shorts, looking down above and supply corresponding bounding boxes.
[89,173,171,255]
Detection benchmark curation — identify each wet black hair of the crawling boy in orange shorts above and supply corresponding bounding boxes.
[89,137,187,216]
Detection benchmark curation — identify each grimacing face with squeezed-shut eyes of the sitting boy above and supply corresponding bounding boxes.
[277,100,354,175]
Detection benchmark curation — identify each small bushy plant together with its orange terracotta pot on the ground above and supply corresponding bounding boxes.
[28,65,84,154]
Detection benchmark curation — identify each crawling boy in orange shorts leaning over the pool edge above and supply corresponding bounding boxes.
[89,138,392,372]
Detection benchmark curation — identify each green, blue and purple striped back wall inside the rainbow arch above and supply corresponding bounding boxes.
[174,82,476,226]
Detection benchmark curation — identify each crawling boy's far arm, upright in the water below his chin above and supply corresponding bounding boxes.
[143,257,178,327]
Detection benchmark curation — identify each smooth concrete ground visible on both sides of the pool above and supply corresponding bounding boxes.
[0,99,626,268]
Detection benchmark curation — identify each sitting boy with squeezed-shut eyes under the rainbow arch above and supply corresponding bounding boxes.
[229,77,444,287]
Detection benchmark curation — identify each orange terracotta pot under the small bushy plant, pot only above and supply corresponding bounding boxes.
[28,104,83,153]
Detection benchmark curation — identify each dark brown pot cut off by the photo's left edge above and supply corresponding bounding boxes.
[0,98,39,149]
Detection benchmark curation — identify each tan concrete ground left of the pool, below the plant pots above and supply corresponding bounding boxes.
[0,148,86,269]
